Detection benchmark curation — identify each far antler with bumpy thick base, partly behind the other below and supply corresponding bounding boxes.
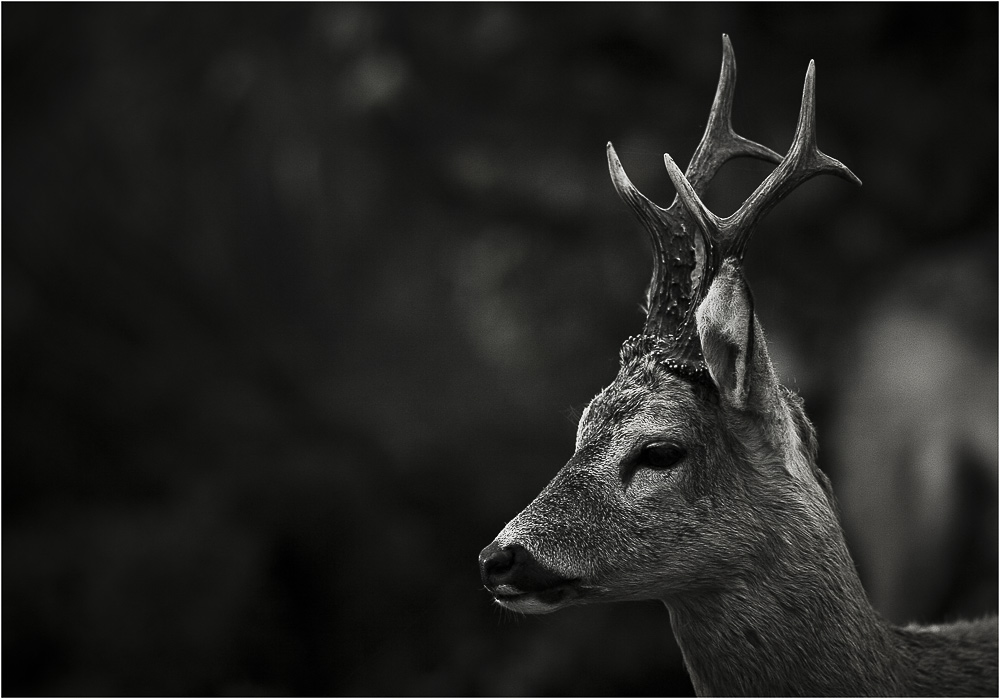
[607,34,781,360]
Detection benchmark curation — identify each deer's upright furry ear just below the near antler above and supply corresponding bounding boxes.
[697,258,756,410]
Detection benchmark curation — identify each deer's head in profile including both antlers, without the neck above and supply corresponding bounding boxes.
[479,36,860,613]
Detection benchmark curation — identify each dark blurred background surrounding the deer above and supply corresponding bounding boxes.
[2,3,998,695]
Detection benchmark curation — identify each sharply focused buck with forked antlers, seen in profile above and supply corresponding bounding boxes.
[479,35,998,696]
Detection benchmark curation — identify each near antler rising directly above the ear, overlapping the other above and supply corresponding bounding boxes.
[663,56,861,296]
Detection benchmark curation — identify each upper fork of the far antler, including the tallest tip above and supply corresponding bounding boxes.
[684,34,781,197]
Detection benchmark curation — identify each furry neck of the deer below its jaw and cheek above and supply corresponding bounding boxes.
[664,512,900,696]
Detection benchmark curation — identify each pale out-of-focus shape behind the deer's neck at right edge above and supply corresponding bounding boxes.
[831,246,998,621]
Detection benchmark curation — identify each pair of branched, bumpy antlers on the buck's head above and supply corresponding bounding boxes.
[608,34,861,366]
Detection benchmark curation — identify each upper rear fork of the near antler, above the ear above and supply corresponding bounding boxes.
[720,61,861,260]
